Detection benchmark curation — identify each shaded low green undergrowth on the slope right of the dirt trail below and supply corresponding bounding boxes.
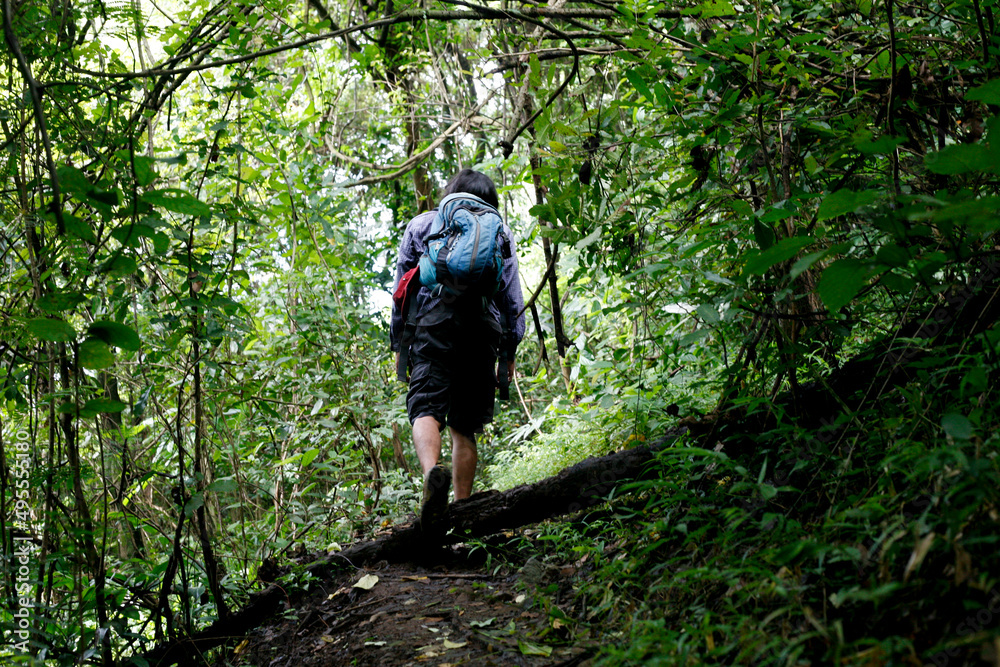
[500,348,1000,666]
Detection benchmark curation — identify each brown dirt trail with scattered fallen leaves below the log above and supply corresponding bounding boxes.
[225,529,600,667]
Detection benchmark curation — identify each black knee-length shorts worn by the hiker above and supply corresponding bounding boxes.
[406,317,500,436]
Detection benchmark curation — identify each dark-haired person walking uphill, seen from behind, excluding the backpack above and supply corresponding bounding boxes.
[390,169,524,531]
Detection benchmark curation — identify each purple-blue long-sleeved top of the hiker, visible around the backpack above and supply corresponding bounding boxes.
[389,211,524,358]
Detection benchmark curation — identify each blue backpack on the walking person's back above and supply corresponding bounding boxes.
[419,192,511,298]
